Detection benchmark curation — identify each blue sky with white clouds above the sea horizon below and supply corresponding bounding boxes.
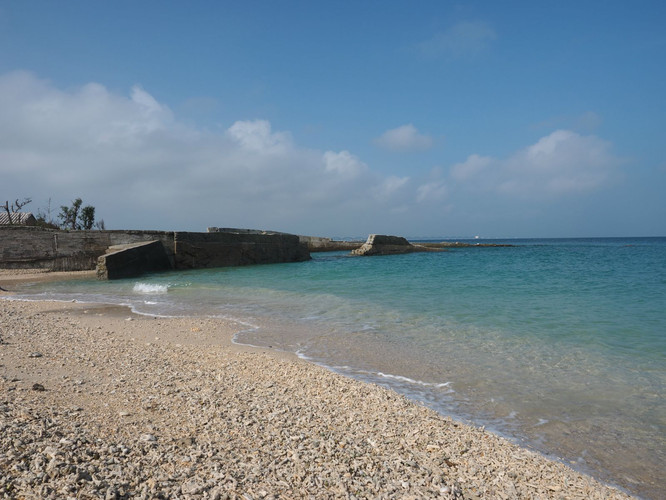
[0,0,666,238]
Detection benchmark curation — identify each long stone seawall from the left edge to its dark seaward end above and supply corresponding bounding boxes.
[0,226,310,271]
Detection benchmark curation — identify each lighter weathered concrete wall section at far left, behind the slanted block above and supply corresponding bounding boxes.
[0,226,174,271]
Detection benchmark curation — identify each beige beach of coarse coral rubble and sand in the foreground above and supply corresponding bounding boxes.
[0,271,630,498]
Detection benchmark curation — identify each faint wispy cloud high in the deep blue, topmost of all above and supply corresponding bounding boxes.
[417,21,497,59]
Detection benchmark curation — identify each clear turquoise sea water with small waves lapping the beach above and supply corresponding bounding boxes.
[10,238,666,498]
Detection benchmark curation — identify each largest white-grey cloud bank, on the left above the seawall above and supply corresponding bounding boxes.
[0,72,410,235]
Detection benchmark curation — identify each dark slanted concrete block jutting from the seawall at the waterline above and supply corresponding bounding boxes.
[97,240,173,280]
